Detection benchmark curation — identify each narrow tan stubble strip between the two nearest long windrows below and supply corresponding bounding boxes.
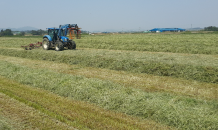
[0,55,218,100]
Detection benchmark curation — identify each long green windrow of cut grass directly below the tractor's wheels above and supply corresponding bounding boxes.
[0,48,218,83]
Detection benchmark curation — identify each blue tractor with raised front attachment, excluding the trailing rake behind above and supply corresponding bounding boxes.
[42,24,81,51]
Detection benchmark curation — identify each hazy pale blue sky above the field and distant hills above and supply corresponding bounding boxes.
[0,0,218,31]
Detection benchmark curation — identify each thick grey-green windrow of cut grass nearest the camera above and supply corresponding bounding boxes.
[0,61,218,129]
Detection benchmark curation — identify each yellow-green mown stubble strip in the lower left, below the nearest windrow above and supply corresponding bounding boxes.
[0,77,164,130]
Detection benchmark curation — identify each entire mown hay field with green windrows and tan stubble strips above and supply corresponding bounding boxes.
[0,33,218,130]
